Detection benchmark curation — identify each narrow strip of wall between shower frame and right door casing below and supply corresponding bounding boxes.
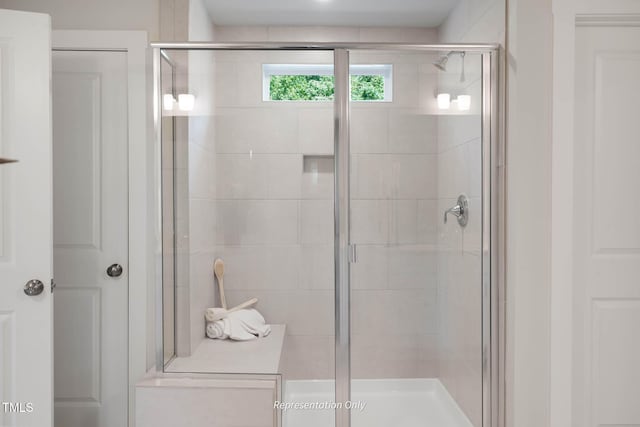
[506,0,552,427]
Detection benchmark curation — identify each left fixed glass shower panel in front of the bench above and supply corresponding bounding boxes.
[161,49,335,426]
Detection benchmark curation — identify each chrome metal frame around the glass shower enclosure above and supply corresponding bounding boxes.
[151,42,504,427]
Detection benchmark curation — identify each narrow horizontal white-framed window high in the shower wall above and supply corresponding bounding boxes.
[262,64,392,102]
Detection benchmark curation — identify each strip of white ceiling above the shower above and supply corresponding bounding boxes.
[204,0,458,27]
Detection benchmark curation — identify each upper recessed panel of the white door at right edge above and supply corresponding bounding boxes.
[588,51,640,255]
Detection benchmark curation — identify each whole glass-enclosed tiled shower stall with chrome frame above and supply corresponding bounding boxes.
[153,43,501,427]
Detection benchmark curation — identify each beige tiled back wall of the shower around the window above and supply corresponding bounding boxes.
[182,29,438,378]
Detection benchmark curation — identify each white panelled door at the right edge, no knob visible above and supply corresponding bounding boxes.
[573,24,640,427]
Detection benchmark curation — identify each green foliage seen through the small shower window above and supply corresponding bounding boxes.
[269,75,384,101]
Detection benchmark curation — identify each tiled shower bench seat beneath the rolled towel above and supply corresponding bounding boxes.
[135,325,286,427]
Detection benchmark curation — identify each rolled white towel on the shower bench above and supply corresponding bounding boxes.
[206,308,271,341]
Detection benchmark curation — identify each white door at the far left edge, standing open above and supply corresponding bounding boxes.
[0,10,53,427]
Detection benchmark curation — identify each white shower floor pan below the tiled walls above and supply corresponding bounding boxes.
[282,378,472,427]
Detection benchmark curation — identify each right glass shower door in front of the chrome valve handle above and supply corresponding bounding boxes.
[350,50,482,427]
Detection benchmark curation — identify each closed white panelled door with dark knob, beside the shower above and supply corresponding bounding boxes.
[53,51,128,427]
